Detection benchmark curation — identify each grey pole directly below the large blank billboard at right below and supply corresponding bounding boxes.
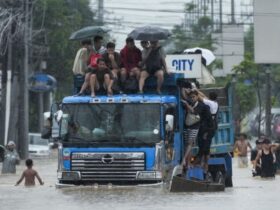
[265,64,271,138]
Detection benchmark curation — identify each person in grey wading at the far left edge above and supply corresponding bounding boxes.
[2,141,20,174]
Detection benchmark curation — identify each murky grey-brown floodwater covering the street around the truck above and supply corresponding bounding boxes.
[0,151,280,210]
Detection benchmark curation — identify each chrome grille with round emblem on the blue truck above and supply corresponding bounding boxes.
[71,152,145,181]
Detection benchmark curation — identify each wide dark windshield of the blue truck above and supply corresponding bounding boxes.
[61,103,160,144]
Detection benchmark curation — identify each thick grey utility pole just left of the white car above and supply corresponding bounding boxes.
[19,0,30,159]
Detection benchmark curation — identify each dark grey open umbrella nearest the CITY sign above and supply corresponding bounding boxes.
[128,26,171,41]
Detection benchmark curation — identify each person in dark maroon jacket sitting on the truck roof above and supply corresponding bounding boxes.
[120,37,142,83]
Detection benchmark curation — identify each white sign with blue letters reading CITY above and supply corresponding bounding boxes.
[165,54,202,78]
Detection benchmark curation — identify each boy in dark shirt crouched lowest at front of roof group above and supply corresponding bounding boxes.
[90,58,113,97]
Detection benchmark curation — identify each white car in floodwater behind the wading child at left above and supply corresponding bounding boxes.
[28,133,50,157]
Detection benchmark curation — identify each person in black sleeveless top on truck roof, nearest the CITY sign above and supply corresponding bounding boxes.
[139,41,167,94]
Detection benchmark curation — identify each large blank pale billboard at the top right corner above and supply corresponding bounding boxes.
[254,0,280,64]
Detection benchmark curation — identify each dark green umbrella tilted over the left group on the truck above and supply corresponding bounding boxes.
[69,26,111,40]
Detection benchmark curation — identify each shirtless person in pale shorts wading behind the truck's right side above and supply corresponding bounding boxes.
[233,133,252,168]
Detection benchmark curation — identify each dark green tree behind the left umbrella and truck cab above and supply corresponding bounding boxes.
[33,0,94,97]
